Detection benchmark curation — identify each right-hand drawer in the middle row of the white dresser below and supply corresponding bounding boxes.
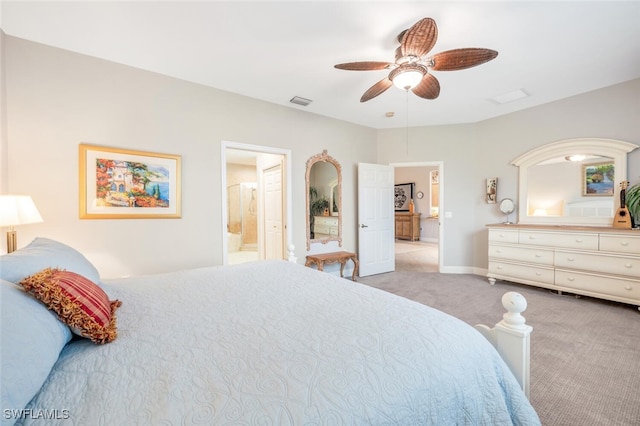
[555,250,640,278]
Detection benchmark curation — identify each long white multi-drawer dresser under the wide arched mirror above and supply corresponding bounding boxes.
[487,224,640,306]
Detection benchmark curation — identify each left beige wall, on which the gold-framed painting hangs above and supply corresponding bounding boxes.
[1,36,376,277]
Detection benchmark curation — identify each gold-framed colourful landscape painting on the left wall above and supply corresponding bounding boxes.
[79,144,181,219]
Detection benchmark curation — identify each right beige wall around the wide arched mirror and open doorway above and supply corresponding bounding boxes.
[378,79,640,273]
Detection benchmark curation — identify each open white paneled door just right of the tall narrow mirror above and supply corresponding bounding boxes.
[358,163,396,277]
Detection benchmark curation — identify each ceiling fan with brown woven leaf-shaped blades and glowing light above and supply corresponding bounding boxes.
[335,18,498,102]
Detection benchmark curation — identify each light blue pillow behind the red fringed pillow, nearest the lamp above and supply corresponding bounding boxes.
[0,237,100,284]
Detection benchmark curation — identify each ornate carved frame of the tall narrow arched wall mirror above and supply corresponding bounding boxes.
[305,149,342,250]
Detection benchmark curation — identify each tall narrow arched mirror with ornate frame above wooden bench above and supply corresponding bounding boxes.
[305,149,342,250]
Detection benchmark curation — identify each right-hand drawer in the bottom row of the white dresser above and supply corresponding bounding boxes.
[555,269,640,304]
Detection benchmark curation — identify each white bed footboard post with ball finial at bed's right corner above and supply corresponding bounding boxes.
[476,291,533,398]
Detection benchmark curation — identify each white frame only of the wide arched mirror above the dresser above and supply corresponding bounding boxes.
[511,138,638,226]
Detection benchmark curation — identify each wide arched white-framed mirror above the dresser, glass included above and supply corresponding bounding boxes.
[511,138,637,226]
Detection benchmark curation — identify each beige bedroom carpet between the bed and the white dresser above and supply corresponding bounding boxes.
[359,272,640,426]
